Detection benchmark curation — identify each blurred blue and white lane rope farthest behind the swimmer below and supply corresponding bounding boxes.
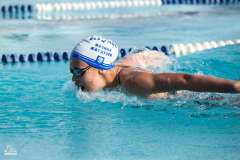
[0,0,240,20]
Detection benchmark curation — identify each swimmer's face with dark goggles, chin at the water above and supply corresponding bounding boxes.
[70,60,101,91]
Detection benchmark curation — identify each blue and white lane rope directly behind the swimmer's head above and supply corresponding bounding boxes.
[0,39,240,64]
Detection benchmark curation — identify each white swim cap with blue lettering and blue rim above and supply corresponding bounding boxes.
[70,36,118,70]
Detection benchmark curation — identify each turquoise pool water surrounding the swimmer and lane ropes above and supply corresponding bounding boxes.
[0,1,240,160]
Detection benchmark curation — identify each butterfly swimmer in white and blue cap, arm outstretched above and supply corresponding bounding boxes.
[70,36,240,98]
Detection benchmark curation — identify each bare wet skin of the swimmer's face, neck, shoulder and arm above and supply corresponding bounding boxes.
[70,51,240,96]
